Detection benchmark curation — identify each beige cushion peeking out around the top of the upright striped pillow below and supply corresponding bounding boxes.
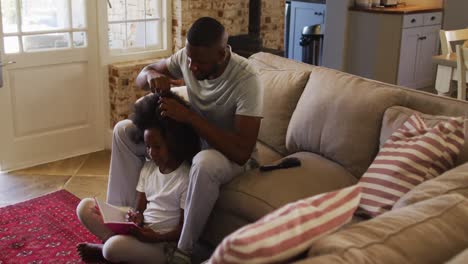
[380,106,468,164]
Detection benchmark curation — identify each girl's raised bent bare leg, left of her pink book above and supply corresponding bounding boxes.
[76,198,114,242]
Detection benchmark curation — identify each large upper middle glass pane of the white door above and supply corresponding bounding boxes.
[21,0,70,32]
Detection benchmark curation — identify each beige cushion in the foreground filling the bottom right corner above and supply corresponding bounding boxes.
[298,194,468,264]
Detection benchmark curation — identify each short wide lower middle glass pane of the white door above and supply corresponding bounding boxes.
[23,33,70,52]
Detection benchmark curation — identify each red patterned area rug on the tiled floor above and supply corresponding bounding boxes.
[0,190,100,264]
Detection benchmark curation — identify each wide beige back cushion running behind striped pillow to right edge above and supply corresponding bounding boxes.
[286,67,468,178]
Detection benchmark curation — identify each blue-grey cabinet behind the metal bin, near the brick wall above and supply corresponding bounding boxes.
[288,1,326,61]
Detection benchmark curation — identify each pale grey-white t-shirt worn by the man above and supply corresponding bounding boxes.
[166,48,263,148]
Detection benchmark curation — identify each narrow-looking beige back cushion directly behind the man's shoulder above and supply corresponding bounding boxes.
[258,69,309,155]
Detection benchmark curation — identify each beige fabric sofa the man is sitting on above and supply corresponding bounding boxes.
[197,53,468,264]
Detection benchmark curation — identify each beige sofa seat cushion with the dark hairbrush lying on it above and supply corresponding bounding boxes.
[204,152,357,246]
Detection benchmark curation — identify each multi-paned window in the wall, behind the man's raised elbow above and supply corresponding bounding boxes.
[107,0,169,55]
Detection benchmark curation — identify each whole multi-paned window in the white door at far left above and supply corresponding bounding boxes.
[1,0,87,54]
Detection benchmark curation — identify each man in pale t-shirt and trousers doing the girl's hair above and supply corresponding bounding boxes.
[107,17,263,263]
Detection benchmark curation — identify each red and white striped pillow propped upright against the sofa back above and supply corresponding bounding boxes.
[357,114,465,217]
